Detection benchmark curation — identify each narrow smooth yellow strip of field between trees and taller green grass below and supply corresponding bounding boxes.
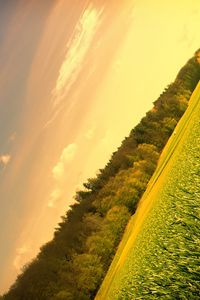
[95,82,200,300]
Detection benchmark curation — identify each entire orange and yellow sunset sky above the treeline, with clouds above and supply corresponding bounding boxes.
[0,0,200,293]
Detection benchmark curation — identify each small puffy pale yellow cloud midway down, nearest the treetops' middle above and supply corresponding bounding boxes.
[52,143,77,181]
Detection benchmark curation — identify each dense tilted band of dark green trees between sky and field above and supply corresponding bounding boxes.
[2,50,200,300]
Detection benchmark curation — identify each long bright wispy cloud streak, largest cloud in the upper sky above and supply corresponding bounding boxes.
[52,5,103,106]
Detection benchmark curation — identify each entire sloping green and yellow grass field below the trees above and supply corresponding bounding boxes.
[95,83,200,300]
